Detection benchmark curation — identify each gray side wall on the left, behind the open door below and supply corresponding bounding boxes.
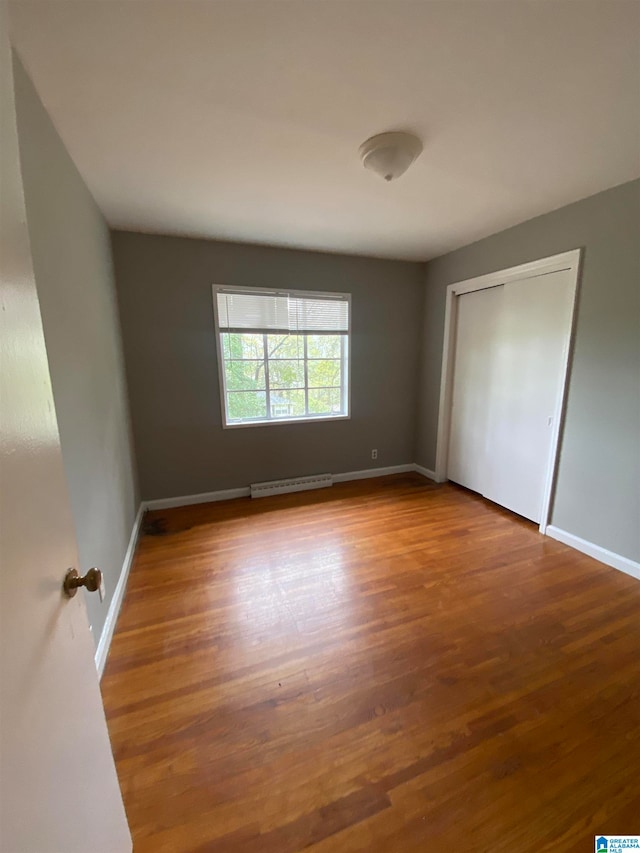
[14,59,139,645]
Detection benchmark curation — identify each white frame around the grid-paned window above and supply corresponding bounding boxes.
[212,284,352,429]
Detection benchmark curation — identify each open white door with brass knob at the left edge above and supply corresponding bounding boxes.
[0,13,131,853]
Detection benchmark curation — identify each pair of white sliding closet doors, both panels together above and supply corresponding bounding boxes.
[447,270,573,522]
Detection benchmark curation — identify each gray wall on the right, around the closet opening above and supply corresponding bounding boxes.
[416,181,640,560]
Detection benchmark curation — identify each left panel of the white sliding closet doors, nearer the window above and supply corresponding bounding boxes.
[447,285,504,494]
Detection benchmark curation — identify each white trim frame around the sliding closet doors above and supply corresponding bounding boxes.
[435,249,582,533]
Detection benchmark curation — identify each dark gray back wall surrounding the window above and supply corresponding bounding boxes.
[113,232,423,499]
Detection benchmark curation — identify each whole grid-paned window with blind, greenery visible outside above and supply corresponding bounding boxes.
[213,287,351,427]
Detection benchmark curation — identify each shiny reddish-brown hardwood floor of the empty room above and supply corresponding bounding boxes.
[102,474,640,853]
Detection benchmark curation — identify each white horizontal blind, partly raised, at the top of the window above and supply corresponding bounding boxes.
[216,289,349,334]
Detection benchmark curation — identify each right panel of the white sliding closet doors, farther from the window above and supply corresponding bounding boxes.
[482,270,573,523]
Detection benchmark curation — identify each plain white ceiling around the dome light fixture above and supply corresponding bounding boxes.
[6,0,640,260]
